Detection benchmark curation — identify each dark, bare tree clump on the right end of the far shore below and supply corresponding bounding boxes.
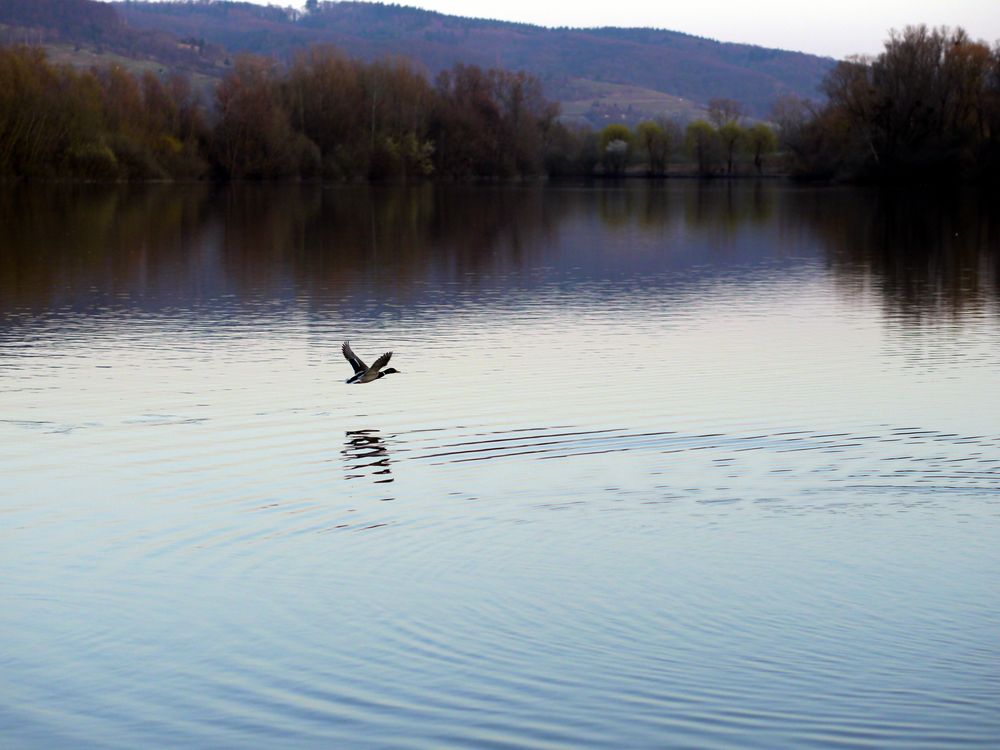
[772,26,1000,181]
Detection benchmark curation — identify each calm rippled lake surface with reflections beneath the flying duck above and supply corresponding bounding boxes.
[0,180,1000,750]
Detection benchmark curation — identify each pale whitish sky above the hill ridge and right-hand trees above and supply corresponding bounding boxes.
[230,0,1000,57]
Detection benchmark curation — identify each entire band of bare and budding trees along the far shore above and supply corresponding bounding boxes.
[0,26,1000,181]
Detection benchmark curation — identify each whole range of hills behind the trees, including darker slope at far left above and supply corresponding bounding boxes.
[0,0,835,120]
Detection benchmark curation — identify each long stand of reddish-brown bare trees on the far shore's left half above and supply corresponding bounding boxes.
[0,47,561,180]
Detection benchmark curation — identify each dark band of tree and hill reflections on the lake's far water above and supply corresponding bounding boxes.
[0,183,1000,323]
